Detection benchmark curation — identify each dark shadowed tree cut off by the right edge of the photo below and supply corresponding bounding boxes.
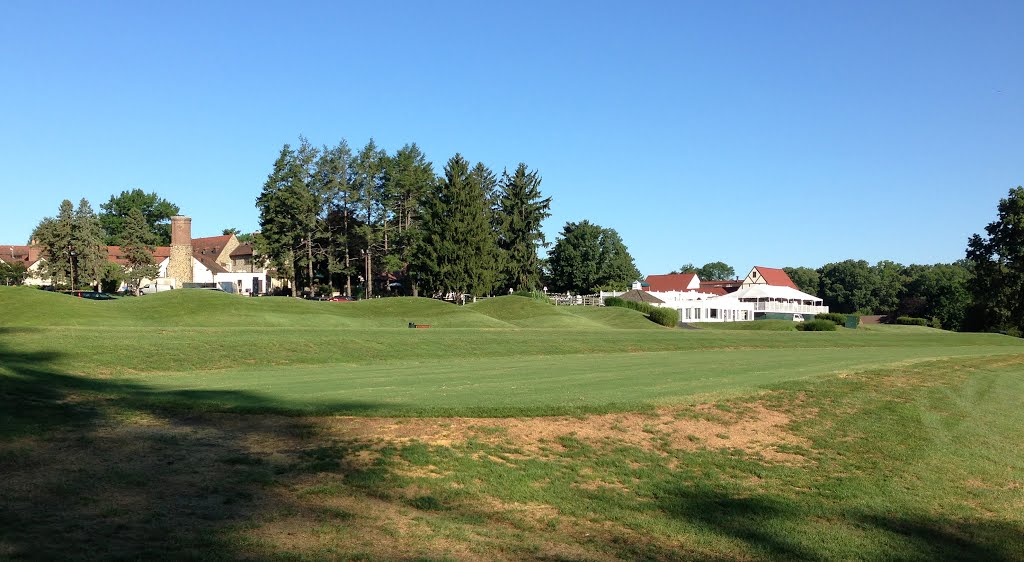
[967,186,1024,335]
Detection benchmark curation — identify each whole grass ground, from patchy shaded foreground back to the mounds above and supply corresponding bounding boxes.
[0,288,1024,560]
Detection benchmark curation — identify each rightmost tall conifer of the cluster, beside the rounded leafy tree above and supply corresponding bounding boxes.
[496,163,551,290]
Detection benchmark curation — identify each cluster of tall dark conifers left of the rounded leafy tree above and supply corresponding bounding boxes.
[253,138,551,297]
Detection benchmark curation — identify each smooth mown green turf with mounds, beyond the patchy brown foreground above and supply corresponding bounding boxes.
[0,290,1024,416]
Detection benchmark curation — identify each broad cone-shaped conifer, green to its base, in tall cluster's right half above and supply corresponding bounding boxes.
[412,154,498,295]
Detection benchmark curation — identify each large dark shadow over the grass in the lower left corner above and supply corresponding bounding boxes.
[0,329,382,560]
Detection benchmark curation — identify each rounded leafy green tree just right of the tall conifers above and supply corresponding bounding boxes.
[548,220,640,294]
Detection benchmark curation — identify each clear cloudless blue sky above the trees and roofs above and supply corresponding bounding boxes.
[0,0,1024,274]
